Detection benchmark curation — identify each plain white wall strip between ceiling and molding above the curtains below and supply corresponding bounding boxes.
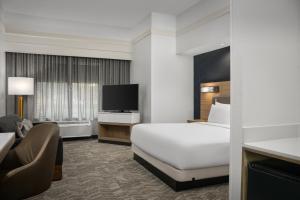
[3,11,131,41]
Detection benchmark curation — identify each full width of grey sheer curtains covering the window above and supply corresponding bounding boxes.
[6,53,130,121]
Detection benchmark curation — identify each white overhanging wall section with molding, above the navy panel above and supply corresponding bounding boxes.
[176,0,230,55]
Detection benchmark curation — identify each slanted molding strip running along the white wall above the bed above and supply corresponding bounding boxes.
[176,6,230,36]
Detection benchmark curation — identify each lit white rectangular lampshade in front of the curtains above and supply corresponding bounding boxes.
[8,77,34,95]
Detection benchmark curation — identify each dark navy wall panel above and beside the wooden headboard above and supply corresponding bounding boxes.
[194,47,230,119]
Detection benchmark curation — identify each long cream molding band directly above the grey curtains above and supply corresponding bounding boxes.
[4,33,132,60]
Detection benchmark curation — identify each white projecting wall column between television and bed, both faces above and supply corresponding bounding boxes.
[131,13,193,122]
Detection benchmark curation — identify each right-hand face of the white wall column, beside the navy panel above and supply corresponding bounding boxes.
[151,34,194,123]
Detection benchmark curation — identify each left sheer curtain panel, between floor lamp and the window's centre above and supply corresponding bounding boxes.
[34,56,70,121]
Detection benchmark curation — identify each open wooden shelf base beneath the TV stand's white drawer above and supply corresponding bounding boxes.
[98,122,136,145]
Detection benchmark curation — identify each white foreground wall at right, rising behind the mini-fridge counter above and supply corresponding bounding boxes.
[230,0,300,200]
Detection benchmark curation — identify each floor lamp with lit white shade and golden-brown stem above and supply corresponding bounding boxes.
[7,77,34,119]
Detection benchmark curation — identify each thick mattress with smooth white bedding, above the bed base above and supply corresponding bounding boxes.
[131,123,230,170]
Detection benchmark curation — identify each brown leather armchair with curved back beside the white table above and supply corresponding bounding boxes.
[0,124,59,200]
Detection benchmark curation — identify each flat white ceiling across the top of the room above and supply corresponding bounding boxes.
[0,0,201,28]
